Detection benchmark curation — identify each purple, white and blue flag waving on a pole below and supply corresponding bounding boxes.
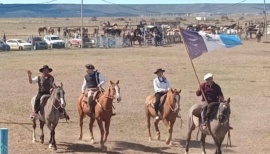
[181,29,242,59]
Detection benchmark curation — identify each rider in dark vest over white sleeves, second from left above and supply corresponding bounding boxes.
[82,64,105,115]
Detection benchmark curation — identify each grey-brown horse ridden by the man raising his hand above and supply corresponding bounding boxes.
[31,83,66,150]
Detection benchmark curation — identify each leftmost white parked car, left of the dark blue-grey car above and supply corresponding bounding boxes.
[6,39,32,51]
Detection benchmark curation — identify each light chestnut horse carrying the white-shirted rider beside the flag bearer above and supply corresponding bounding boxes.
[145,89,181,144]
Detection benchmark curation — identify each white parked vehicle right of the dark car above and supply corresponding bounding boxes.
[44,35,66,48]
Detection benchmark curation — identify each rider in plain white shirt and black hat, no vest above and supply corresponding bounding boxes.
[153,68,171,120]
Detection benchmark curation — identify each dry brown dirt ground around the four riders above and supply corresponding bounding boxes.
[0,17,270,154]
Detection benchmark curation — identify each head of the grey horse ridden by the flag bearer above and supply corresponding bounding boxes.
[217,98,231,123]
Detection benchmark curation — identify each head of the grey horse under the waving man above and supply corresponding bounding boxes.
[52,82,66,108]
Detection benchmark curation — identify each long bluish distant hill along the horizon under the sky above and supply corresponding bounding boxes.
[0,4,270,18]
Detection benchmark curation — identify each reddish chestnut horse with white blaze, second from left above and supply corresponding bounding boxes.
[78,80,121,148]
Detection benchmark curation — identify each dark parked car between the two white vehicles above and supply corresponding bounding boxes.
[27,36,49,50]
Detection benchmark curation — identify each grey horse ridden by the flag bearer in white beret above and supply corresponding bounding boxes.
[185,98,231,154]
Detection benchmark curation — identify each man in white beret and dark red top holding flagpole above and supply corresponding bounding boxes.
[196,73,224,129]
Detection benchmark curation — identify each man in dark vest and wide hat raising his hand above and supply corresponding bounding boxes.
[27,65,69,119]
